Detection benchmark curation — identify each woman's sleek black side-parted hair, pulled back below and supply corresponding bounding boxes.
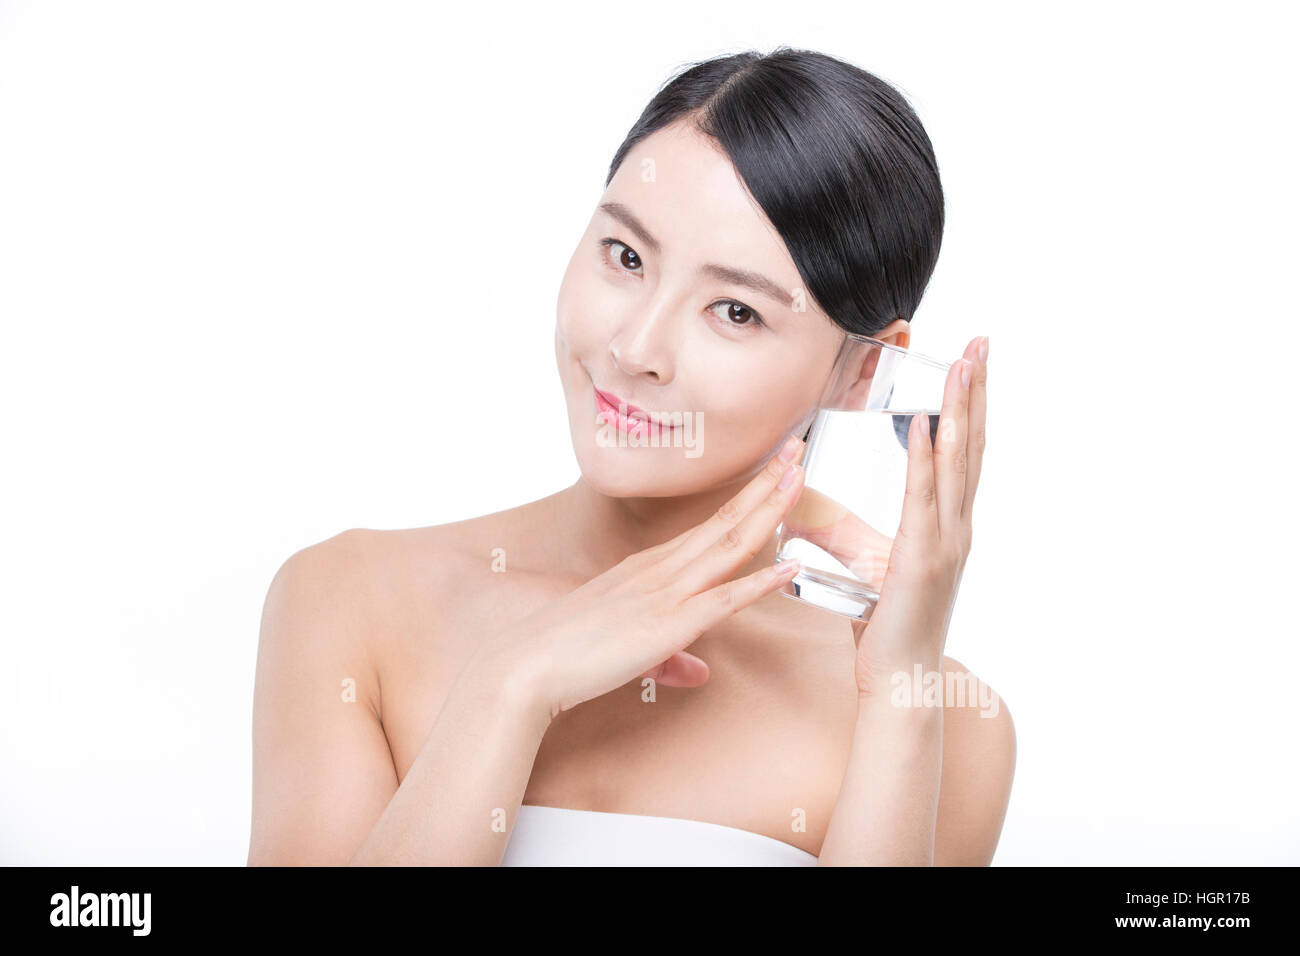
[605,47,944,336]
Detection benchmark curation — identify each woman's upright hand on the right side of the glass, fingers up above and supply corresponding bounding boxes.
[853,337,988,697]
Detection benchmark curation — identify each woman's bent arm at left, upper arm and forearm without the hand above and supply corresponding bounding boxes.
[248,529,550,865]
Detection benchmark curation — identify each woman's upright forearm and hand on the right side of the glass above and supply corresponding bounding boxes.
[819,337,998,865]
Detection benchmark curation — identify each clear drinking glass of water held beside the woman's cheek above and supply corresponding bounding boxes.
[776,336,952,620]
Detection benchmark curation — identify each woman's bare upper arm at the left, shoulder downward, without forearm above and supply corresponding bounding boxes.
[248,529,398,866]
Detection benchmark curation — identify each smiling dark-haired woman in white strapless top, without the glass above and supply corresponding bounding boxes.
[248,48,1014,865]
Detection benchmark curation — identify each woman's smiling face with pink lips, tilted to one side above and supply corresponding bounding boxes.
[555,115,844,497]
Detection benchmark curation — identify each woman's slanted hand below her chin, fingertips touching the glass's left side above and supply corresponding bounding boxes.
[467,436,805,718]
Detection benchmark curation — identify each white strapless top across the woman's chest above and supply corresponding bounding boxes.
[501,804,816,866]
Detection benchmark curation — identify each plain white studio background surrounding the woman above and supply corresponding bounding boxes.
[0,0,1300,865]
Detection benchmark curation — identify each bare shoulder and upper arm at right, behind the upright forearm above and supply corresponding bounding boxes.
[935,657,1015,866]
